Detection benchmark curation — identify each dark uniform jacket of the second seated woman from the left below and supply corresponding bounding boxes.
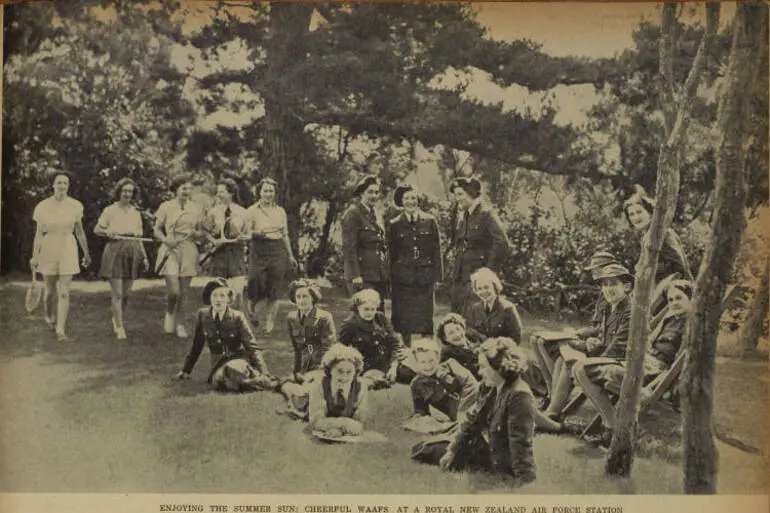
[286,306,337,374]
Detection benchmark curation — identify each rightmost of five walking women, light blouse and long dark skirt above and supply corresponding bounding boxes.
[246,178,297,333]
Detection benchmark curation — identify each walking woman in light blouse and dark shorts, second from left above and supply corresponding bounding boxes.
[94,178,150,340]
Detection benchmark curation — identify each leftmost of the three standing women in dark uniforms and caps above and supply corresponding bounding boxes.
[342,175,389,311]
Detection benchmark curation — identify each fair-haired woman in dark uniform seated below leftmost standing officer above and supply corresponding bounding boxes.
[340,289,415,389]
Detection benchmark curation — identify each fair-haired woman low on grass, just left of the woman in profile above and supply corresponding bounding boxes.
[409,338,478,421]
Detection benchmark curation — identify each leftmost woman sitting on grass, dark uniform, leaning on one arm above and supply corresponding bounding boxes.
[177,278,278,392]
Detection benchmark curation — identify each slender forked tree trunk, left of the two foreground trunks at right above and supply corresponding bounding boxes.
[605,3,719,477]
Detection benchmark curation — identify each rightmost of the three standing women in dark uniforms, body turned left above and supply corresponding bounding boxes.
[449,178,510,316]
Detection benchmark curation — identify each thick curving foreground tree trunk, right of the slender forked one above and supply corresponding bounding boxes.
[682,2,767,494]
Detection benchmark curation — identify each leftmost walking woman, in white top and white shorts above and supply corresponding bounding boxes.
[29,171,91,341]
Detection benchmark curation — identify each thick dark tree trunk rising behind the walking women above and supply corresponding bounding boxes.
[261,2,313,255]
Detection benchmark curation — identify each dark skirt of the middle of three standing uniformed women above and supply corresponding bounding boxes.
[391,283,435,334]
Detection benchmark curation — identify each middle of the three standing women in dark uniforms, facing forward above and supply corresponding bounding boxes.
[388,185,443,346]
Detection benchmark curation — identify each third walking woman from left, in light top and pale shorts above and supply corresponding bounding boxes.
[153,176,203,338]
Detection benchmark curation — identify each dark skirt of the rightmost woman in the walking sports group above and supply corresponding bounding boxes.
[247,239,289,301]
